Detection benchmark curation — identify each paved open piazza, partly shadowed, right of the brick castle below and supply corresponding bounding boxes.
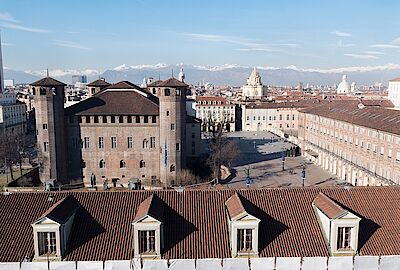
[225,131,343,188]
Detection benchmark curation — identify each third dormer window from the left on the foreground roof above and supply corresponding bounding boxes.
[225,193,260,257]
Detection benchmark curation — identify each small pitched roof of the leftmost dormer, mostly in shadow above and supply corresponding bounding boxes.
[38,195,79,224]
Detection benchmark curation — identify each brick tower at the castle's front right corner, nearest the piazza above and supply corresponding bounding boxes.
[153,78,188,186]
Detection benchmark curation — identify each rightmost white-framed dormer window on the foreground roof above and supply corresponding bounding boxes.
[313,193,361,256]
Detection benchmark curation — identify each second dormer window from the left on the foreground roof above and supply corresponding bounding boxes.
[132,195,164,259]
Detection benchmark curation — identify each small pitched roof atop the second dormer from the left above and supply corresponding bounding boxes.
[133,194,164,222]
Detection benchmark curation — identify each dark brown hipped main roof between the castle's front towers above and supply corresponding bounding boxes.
[66,89,158,115]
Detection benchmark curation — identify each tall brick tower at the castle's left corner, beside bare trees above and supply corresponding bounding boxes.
[30,77,68,184]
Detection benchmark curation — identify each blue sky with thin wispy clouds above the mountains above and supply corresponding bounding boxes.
[0,0,400,70]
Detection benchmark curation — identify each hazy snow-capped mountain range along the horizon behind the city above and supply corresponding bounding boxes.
[4,64,400,86]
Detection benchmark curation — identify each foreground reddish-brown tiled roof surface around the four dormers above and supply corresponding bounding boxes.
[0,187,400,261]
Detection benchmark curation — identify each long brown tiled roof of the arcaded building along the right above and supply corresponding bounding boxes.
[301,101,400,135]
